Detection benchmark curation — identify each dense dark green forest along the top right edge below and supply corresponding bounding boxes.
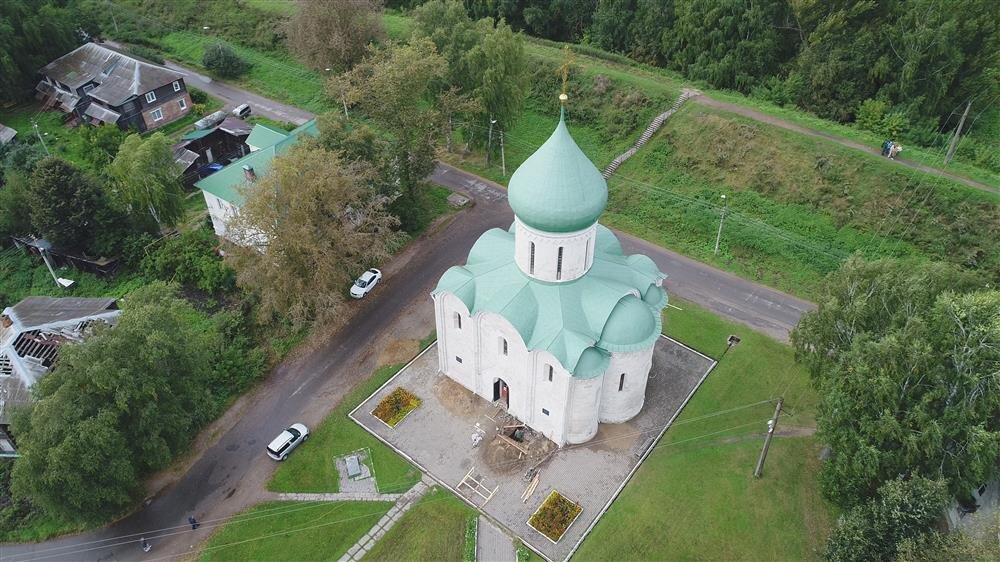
[408,0,1000,165]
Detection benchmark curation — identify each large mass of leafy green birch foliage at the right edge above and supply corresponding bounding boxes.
[792,260,1000,506]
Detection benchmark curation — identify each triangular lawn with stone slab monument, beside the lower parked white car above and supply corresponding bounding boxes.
[267,364,420,493]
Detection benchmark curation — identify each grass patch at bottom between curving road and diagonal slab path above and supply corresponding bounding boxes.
[196,502,392,562]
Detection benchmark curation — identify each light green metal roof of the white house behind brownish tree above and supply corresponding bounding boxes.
[194,119,319,206]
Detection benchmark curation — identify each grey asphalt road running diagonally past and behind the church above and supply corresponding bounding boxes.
[0,54,811,562]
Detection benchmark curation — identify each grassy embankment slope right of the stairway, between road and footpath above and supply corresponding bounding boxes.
[604,104,1000,297]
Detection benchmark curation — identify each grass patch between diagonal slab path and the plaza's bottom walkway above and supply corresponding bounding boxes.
[365,489,475,562]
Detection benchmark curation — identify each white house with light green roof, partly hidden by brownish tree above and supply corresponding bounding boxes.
[194,119,319,240]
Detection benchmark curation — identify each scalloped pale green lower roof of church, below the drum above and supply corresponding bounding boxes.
[434,225,667,378]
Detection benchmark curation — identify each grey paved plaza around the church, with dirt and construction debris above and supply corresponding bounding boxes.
[351,337,715,561]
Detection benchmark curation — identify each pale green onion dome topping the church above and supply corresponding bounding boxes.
[507,110,608,232]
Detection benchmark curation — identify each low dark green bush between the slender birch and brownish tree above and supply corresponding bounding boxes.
[140,228,235,293]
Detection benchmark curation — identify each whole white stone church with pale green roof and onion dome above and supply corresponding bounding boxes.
[432,107,667,446]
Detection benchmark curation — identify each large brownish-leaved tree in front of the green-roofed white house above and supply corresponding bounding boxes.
[226,144,401,326]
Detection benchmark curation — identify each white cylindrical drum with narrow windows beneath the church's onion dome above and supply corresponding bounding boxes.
[514,217,597,282]
